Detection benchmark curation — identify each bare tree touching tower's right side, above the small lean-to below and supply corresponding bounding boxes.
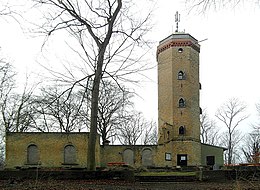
[200,109,219,145]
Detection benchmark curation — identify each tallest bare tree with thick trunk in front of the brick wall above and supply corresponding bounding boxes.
[34,0,153,170]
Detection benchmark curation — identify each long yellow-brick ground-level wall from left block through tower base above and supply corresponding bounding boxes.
[6,133,223,169]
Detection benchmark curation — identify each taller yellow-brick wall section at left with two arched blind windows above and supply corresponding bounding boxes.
[6,133,100,168]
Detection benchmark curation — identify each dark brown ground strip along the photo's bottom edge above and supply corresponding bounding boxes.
[0,180,260,190]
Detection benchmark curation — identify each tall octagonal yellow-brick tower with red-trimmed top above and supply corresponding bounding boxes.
[157,32,201,166]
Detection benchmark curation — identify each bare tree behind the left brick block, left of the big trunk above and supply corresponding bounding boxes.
[35,85,87,133]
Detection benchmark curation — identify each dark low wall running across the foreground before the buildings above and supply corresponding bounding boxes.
[0,169,260,182]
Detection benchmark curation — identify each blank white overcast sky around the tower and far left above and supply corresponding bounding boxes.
[0,0,260,131]
